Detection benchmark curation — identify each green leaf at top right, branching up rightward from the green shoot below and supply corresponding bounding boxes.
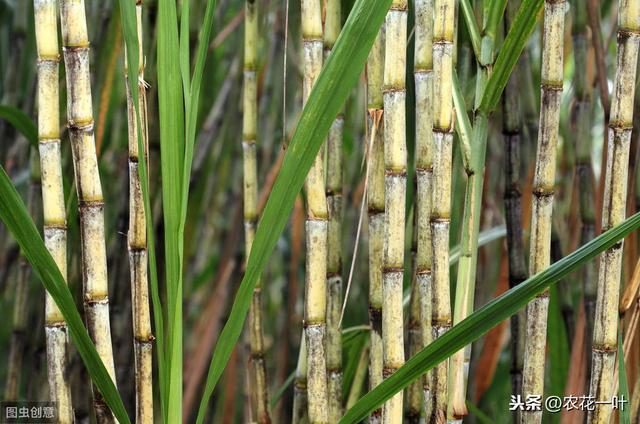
[479,0,544,115]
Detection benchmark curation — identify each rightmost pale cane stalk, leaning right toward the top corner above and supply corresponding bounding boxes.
[588,0,640,423]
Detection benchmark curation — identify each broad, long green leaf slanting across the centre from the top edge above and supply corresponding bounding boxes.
[197,0,391,423]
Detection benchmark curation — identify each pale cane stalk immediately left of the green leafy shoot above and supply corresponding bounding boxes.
[428,0,456,423]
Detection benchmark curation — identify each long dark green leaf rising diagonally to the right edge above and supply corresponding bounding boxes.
[340,213,640,423]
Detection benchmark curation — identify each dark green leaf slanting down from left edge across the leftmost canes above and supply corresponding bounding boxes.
[0,166,130,424]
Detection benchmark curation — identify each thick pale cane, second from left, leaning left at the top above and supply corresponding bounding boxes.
[60,0,115,423]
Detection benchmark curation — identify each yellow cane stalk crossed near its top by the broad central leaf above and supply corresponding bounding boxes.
[302,0,329,424]
